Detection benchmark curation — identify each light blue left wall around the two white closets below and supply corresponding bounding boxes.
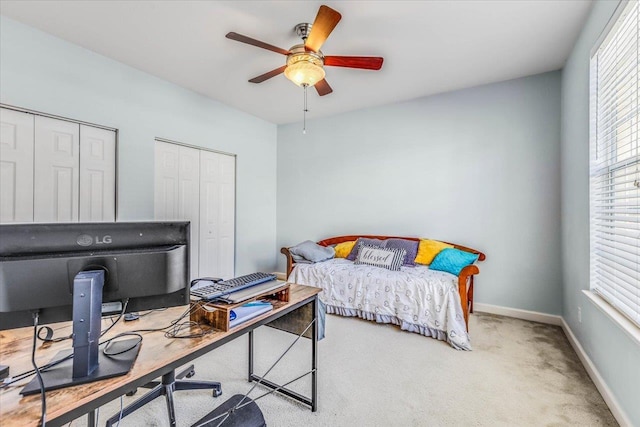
[0,17,277,274]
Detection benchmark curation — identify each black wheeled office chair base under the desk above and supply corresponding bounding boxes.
[106,365,222,427]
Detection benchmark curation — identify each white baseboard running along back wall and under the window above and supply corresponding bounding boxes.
[473,303,632,427]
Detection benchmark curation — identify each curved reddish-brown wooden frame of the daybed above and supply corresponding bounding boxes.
[280,235,486,330]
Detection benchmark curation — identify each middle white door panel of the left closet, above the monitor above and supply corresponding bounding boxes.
[33,116,80,222]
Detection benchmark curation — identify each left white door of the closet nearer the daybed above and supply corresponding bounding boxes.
[154,141,201,279]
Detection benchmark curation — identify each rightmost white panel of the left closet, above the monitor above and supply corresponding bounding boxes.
[80,125,116,222]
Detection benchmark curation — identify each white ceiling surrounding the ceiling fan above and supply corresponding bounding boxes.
[0,0,591,124]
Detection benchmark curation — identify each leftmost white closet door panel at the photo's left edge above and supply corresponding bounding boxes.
[0,108,34,223]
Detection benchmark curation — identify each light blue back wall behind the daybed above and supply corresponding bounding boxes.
[277,72,562,314]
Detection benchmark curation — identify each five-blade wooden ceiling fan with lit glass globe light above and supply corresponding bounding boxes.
[226,5,383,96]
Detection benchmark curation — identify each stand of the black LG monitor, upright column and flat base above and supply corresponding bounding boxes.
[20,270,140,396]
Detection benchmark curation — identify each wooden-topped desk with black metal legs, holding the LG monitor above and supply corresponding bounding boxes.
[0,284,320,427]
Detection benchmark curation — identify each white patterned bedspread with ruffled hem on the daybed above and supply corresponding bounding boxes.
[288,258,471,350]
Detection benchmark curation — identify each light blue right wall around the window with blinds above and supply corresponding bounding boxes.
[561,1,640,426]
